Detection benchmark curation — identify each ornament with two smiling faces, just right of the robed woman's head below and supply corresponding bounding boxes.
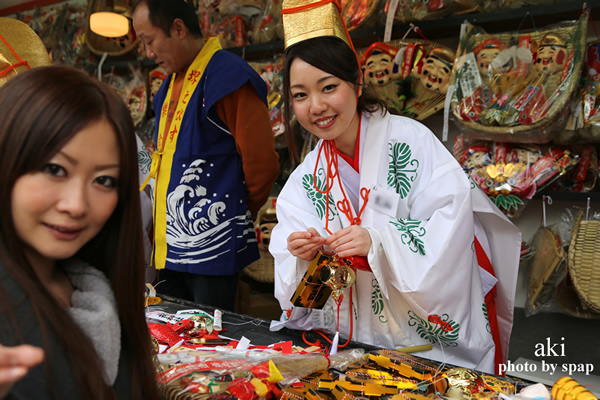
[360,39,454,120]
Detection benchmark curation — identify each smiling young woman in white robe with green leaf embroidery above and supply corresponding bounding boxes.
[269,37,521,373]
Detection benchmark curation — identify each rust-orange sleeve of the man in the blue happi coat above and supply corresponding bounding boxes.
[215,82,279,218]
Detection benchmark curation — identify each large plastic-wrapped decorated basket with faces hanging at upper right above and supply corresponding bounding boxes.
[451,8,589,143]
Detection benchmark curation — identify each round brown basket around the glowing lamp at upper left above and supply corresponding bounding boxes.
[85,0,139,56]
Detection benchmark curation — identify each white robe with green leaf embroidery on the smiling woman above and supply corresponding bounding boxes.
[269,113,521,373]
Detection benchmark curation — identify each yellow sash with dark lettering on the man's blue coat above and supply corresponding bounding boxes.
[140,38,221,269]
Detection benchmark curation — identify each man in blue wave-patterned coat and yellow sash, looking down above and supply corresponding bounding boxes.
[133,0,279,310]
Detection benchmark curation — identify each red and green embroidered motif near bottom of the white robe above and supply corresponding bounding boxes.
[408,310,460,347]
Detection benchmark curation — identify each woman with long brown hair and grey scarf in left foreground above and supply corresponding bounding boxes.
[0,66,157,399]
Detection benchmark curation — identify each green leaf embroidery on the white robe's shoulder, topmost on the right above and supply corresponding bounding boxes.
[387,143,419,199]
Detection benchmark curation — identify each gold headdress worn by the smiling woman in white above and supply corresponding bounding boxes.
[281,0,354,50]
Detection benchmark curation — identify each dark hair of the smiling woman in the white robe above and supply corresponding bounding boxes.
[283,36,387,163]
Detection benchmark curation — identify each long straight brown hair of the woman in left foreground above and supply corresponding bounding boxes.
[0,66,157,400]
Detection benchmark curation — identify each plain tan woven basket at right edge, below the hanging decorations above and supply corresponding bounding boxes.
[567,213,600,313]
